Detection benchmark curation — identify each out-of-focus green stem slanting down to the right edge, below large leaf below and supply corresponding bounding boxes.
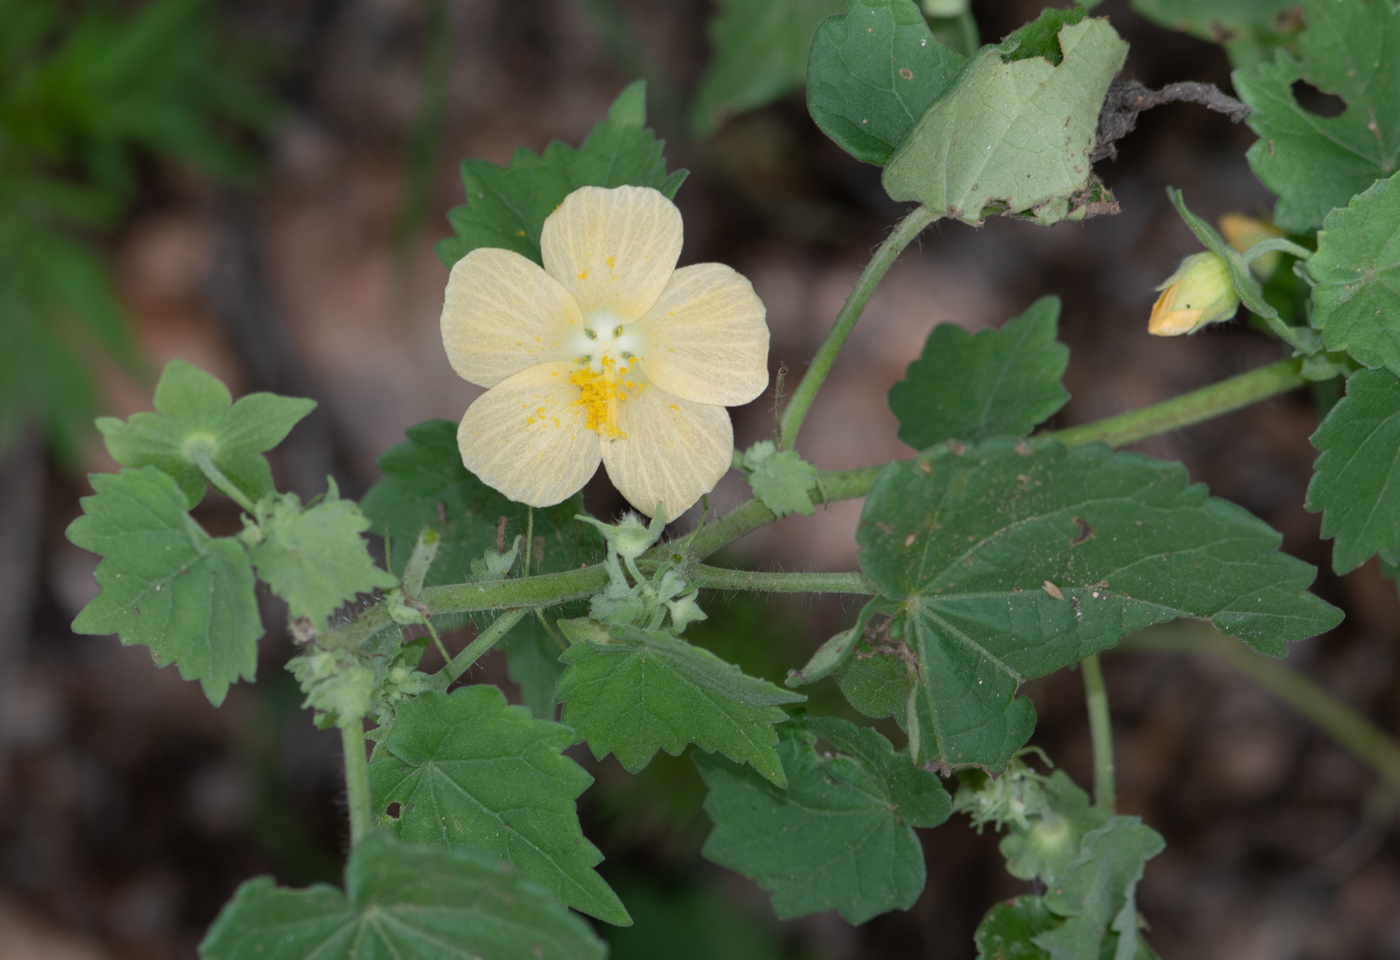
[1120,623,1400,786]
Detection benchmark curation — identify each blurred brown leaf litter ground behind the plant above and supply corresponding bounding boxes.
[0,0,1400,960]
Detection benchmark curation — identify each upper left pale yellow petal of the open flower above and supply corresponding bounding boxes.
[442,246,581,386]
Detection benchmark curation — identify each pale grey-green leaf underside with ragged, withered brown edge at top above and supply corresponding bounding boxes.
[883,11,1127,224]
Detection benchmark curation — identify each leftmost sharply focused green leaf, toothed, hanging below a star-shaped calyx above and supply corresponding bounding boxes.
[67,466,262,707]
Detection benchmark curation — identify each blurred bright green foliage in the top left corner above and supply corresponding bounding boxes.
[0,0,273,462]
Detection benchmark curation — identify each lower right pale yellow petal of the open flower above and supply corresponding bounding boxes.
[602,383,734,521]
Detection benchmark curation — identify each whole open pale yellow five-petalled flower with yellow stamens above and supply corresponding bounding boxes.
[442,186,769,519]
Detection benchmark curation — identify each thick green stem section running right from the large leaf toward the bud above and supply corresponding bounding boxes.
[1043,358,1308,446]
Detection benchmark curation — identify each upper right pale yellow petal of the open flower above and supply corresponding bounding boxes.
[637,263,769,407]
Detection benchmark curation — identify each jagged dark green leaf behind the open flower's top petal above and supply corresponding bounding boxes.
[437,80,686,267]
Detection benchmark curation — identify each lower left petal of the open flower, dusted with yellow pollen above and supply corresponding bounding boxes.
[456,362,602,507]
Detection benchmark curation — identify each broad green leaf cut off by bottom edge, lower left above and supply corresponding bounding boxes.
[199,833,608,960]
